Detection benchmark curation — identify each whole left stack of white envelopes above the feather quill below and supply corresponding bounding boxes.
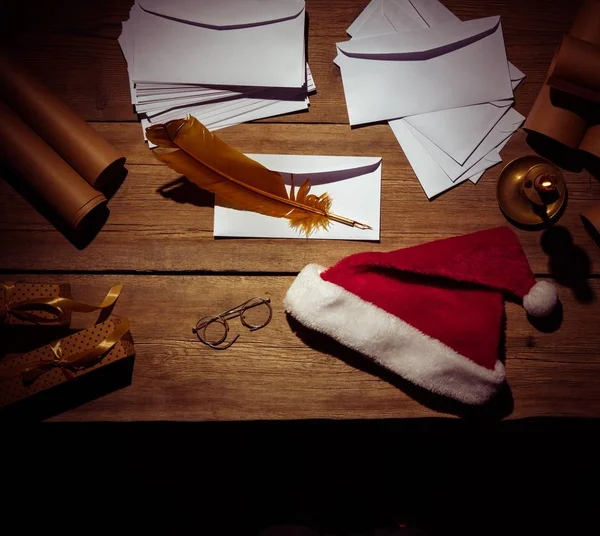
[119,0,315,144]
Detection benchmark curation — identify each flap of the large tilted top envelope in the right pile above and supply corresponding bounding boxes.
[337,17,500,60]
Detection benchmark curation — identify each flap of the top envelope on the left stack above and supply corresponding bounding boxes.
[138,0,304,30]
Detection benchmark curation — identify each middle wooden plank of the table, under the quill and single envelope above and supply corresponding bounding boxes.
[0,123,600,277]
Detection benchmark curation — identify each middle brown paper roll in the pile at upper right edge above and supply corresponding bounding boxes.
[548,35,600,102]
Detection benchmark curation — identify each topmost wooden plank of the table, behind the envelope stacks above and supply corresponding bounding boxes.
[0,0,578,124]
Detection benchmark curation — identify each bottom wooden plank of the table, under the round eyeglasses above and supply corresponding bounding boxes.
[2,275,600,421]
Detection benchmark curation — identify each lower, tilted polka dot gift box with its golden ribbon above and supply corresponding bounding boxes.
[0,316,135,408]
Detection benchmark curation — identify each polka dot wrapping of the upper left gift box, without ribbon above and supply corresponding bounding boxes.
[0,281,72,326]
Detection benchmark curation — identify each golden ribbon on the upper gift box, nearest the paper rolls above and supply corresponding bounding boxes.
[0,281,123,324]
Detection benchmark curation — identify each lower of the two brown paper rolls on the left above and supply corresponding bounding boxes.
[0,101,106,229]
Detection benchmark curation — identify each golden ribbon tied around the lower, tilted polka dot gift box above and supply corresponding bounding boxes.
[0,318,129,384]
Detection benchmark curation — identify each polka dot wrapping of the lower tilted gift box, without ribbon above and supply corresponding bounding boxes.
[0,316,135,408]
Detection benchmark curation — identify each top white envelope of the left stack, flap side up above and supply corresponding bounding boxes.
[130,0,306,88]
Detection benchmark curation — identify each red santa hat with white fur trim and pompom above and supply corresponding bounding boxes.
[284,227,558,404]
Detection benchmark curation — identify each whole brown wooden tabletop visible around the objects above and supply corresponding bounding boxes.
[0,0,600,421]
